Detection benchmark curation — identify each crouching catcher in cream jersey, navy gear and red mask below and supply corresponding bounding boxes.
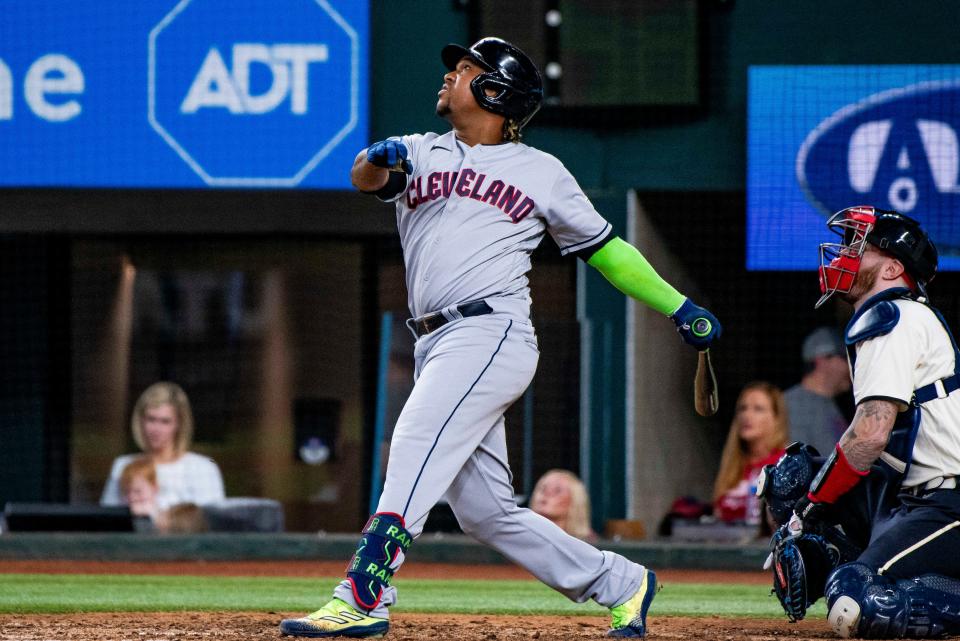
[758,206,960,639]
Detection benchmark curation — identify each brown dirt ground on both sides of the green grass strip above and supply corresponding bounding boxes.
[0,561,834,641]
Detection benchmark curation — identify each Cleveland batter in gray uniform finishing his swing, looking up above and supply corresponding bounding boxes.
[280,38,720,637]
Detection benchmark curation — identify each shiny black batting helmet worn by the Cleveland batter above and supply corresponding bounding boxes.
[440,38,543,127]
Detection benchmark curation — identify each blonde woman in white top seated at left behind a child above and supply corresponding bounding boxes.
[100,382,224,510]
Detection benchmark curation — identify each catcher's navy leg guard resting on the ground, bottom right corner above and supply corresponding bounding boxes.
[827,563,960,639]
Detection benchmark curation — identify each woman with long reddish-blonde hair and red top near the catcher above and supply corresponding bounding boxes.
[713,381,788,525]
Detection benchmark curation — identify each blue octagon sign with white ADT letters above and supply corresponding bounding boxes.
[148,0,360,187]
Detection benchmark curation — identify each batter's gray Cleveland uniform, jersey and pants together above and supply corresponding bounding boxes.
[335,131,645,617]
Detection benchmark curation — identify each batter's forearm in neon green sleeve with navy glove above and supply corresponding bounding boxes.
[587,237,722,350]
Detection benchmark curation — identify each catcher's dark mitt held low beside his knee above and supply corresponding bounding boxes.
[770,525,841,621]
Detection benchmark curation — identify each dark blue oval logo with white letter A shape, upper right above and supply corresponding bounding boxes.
[797,80,960,251]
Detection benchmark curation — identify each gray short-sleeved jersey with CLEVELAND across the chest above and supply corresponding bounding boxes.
[382,131,611,318]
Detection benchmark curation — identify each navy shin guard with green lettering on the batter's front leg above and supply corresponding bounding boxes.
[347,512,413,611]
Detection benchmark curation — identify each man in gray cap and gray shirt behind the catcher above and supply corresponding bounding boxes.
[783,327,851,455]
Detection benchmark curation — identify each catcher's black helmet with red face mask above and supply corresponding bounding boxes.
[814,205,937,307]
